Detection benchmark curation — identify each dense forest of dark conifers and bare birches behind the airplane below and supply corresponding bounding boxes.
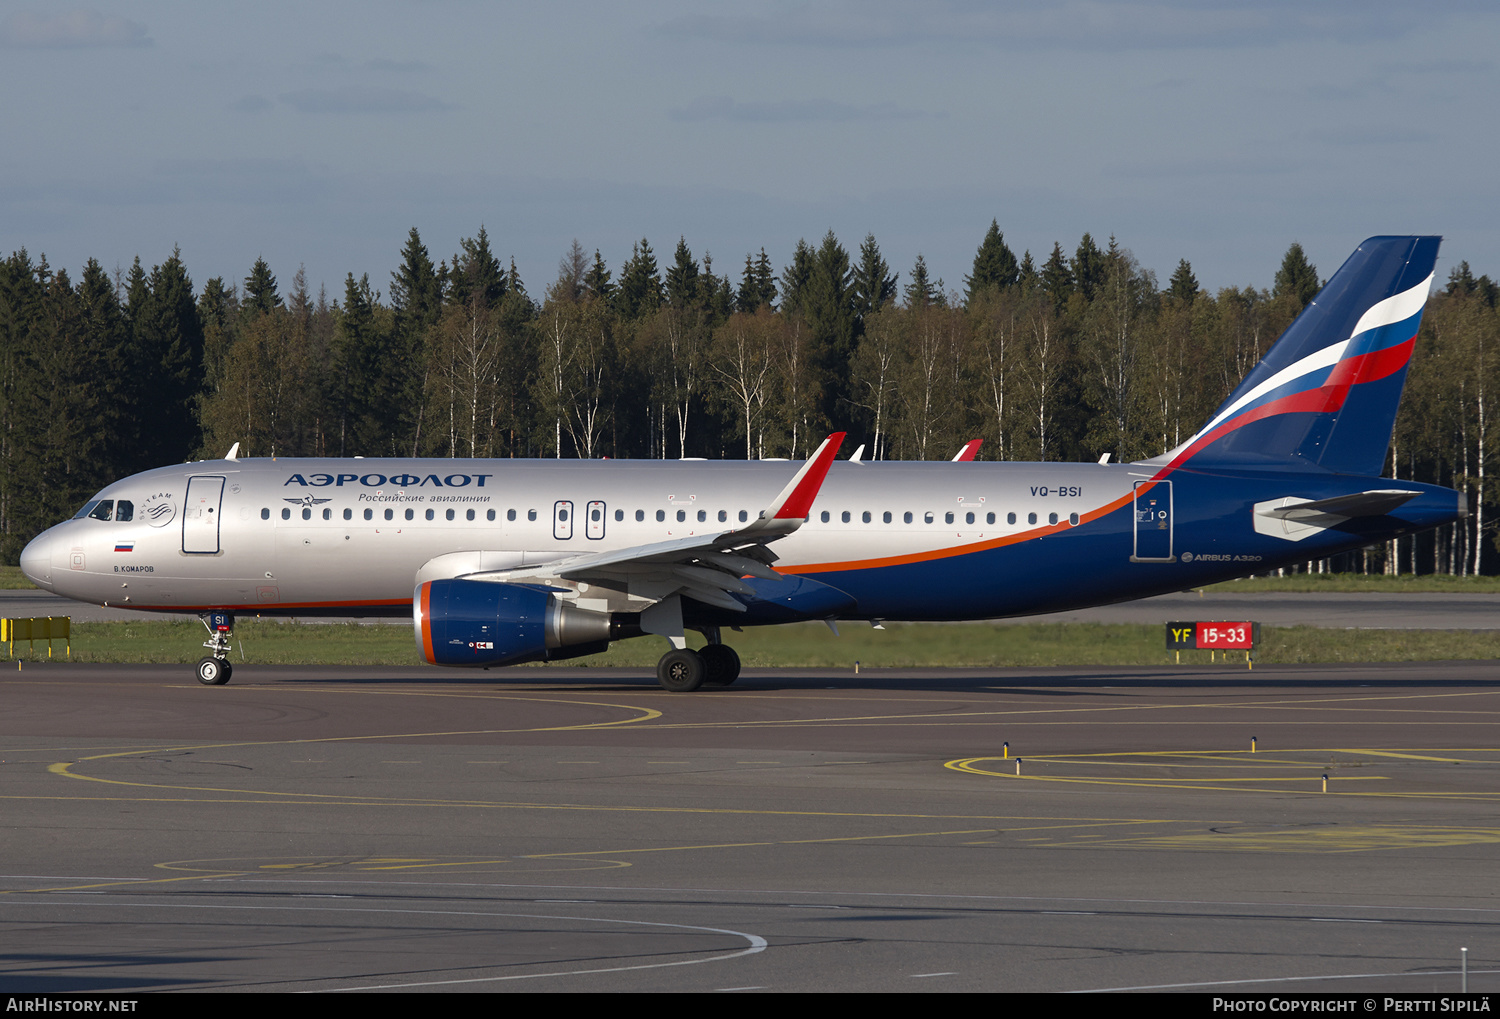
[0,222,1500,573]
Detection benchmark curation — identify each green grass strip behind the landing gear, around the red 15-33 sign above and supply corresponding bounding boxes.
[11,620,1500,669]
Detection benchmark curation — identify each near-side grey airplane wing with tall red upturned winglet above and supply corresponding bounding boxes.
[467,432,845,612]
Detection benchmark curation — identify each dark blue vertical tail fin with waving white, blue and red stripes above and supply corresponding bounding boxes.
[1152,237,1442,476]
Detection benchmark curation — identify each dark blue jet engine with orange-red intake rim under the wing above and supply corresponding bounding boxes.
[411,578,615,668]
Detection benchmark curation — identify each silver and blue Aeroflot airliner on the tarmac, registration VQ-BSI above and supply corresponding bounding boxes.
[21,237,1467,692]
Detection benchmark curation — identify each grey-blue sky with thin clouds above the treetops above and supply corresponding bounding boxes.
[0,0,1500,299]
